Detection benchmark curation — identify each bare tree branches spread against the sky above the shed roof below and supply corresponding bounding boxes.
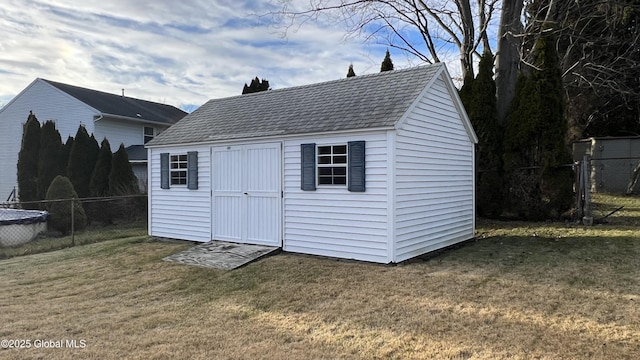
[270,0,499,75]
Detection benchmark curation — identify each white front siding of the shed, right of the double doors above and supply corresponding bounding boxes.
[283,132,391,263]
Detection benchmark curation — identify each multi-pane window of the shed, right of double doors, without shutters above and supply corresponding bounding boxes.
[317,145,347,185]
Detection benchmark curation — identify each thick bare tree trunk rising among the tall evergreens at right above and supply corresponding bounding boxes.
[496,0,523,124]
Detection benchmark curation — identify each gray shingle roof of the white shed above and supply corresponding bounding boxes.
[148,64,444,146]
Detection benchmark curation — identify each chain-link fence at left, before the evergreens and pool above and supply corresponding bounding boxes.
[0,195,147,248]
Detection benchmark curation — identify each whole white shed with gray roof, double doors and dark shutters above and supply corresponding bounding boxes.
[147,64,477,263]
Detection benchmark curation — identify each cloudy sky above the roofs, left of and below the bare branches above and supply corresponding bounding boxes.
[0,0,455,111]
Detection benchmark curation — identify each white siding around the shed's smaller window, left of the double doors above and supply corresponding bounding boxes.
[148,146,211,242]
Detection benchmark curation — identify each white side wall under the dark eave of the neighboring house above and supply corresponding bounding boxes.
[94,118,144,152]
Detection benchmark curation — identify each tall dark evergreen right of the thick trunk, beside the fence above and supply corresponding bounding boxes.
[505,31,573,220]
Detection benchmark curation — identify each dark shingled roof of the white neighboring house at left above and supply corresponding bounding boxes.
[41,79,187,125]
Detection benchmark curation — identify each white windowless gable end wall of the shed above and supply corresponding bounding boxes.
[395,78,474,262]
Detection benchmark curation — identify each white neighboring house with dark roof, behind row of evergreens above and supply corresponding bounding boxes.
[0,79,187,201]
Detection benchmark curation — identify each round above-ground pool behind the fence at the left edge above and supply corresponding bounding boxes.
[0,209,49,246]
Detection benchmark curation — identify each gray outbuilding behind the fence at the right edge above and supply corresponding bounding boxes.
[573,136,640,194]
